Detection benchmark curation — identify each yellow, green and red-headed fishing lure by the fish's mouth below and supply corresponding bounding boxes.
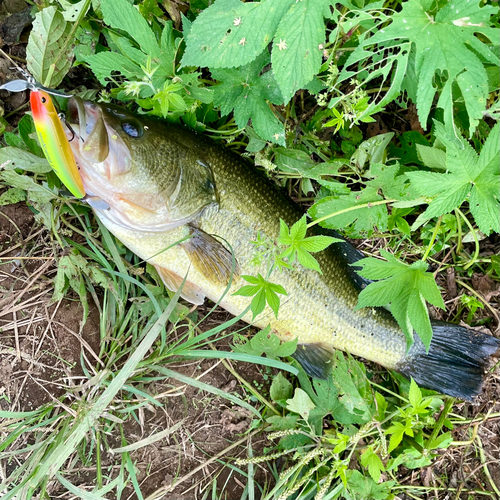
[0,77,85,198]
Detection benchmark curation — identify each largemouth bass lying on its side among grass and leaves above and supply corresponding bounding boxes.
[66,97,500,400]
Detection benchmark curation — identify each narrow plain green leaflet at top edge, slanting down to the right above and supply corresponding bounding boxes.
[101,0,160,56]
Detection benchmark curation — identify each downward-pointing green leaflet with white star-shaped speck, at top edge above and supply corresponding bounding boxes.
[272,0,334,104]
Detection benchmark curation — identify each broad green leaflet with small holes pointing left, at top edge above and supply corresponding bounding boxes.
[182,0,294,69]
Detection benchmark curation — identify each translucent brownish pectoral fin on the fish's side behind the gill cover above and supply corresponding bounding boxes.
[182,227,240,285]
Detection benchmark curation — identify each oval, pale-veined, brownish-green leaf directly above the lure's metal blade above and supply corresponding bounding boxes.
[26,6,73,87]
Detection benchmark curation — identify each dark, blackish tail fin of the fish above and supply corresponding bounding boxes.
[396,321,500,401]
